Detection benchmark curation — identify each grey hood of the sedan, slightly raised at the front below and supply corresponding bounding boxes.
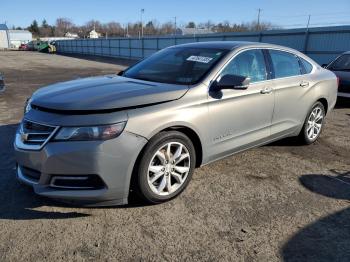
[31,75,189,111]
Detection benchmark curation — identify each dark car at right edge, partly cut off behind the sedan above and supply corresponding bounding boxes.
[324,51,350,98]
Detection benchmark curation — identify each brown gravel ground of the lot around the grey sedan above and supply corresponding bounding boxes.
[0,52,350,261]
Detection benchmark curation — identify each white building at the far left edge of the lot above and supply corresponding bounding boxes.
[0,24,33,49]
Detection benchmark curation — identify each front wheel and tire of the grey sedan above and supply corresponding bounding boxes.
[136,131,196,204]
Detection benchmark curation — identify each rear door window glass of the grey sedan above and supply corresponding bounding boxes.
[269,50,301,78]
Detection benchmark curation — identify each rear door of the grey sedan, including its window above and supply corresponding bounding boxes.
[268,49,312,137]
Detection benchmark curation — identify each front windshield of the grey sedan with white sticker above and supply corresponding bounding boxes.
[123,47,228,85]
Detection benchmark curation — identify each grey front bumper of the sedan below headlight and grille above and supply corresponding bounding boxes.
[14,131,147,206]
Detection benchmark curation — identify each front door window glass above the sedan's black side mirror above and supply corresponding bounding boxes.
[220,49,267,83]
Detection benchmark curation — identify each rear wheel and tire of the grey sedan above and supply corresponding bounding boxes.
[299,102,326,145]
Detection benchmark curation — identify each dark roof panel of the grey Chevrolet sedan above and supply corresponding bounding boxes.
[173,41,277,50]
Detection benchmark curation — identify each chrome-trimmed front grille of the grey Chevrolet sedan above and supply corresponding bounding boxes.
[16,119,58,150]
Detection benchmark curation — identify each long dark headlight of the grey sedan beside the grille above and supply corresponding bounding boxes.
[53,122,126,141]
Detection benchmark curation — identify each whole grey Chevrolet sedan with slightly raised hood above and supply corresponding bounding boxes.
[15,42,337,205]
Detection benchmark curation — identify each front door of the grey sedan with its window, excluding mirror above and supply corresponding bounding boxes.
[209,49,274,160]
